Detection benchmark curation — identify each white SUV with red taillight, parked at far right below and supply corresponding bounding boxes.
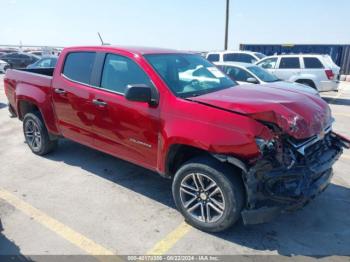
[256,54,340,92]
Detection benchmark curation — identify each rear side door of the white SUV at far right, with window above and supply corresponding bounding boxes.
[274,56,301,80]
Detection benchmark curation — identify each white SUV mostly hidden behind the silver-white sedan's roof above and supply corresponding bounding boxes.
[206,51,265,64]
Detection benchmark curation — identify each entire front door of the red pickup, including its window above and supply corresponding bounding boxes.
[92,54,160,169]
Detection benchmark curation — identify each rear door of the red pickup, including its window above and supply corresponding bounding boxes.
[52,52,96,145]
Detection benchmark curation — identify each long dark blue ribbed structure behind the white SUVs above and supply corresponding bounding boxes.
[240,44,350,75]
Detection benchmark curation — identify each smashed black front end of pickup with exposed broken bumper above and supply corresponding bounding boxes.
[242,126,350,224]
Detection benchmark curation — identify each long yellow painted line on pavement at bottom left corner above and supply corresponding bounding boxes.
[0,188,113,255]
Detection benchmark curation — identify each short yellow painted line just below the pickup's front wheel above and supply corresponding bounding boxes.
[147,222,191,256]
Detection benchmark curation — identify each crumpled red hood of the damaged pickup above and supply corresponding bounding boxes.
[189,85,332,139]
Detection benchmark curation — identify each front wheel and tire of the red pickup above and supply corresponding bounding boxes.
[172,157,244,232]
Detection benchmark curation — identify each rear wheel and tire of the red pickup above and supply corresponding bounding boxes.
[23,112,57,156]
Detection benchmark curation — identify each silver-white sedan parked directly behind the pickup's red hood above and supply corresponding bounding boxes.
[216,62,319,95]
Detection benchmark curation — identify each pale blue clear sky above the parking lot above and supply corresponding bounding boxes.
[0,0,350,50]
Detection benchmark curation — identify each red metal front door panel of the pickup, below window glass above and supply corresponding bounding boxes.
[93,89,160,169]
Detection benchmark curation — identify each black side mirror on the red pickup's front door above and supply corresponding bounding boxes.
[125,84,157,105]
